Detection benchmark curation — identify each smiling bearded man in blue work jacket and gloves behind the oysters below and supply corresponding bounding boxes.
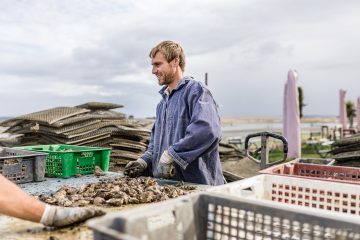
[124,41,224,185]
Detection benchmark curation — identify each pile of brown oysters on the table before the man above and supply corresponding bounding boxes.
[38,177,196,207]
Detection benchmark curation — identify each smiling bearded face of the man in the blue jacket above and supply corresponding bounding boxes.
[151,52,176,86]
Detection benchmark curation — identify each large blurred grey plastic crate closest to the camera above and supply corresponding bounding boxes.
[87,193,360,240]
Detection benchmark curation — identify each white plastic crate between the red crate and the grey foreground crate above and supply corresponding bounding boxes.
[207,174,360,216]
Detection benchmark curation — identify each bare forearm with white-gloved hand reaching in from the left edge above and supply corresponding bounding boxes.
[0,175,105,227]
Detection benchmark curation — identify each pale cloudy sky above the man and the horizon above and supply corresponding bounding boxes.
[0,0,360,117]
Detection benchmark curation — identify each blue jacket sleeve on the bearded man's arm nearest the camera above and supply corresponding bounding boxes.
[169,87,221,170]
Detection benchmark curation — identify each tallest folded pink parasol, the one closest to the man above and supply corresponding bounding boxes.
[283,70,301,158]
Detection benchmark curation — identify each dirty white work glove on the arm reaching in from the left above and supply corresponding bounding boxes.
[40,205,105,227]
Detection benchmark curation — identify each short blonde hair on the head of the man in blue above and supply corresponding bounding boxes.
[149,41,185,72]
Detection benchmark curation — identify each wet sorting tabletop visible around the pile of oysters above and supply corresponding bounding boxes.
[0,172,210,240]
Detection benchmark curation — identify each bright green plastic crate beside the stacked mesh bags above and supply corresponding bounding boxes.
[17,144,110,178]
